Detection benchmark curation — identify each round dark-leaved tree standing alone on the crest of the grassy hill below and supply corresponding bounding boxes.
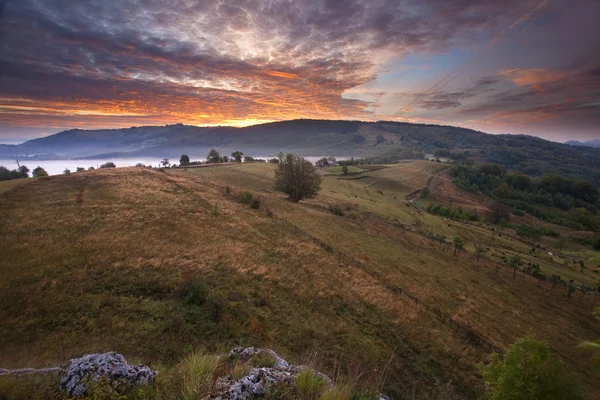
[275,154,322,203]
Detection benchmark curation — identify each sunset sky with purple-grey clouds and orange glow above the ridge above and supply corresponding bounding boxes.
[0,0,600,143]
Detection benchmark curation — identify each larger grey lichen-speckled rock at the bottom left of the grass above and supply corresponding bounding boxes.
[60,352,154,396]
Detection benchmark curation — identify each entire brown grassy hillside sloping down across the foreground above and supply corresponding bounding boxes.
[0,161,600,398]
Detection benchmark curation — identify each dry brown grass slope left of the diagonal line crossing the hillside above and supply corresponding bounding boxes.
[0,168,483,396]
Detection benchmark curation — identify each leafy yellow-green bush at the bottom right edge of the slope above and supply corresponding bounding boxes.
[479,337,584,400]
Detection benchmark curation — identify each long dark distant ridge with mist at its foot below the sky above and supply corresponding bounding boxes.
[0,119,600,186]
